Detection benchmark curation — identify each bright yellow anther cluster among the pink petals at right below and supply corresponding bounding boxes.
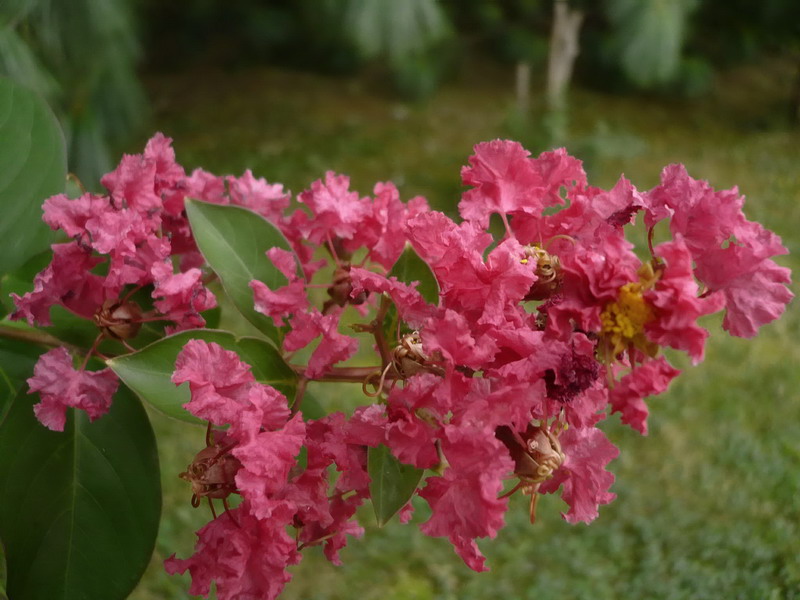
[600,282,653,356]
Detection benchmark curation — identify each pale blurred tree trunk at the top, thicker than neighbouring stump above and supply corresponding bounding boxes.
[547,0,583,111]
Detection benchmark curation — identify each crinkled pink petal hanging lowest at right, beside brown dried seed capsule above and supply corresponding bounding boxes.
[539,427,619,523]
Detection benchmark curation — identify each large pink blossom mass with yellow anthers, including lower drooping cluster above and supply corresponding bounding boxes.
[159,140,792,598]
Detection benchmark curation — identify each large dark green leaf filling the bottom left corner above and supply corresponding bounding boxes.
[0,387,161,600]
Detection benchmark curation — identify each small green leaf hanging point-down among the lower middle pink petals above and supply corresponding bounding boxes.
[367,445,423,527]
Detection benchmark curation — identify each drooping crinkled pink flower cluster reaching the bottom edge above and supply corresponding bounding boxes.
[166,340,369,600]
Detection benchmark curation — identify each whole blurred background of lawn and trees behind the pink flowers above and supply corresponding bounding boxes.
[0,0,800,600]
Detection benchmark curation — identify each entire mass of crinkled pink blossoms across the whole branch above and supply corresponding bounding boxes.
[14,134,792,600]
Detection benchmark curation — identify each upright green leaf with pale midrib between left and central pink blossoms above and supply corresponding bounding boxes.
[186,200,300,344]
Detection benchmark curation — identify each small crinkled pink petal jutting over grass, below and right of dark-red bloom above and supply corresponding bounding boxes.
[608,356,680,435]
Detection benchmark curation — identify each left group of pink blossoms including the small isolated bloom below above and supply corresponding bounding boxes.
[11,133,296,431]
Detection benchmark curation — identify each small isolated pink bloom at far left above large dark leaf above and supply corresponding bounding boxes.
[28,348,119,431]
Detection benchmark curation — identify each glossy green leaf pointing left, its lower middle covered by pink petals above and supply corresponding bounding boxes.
[107,329,297,423]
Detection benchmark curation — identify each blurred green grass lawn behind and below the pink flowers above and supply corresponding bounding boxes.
[129,57,800,600]
